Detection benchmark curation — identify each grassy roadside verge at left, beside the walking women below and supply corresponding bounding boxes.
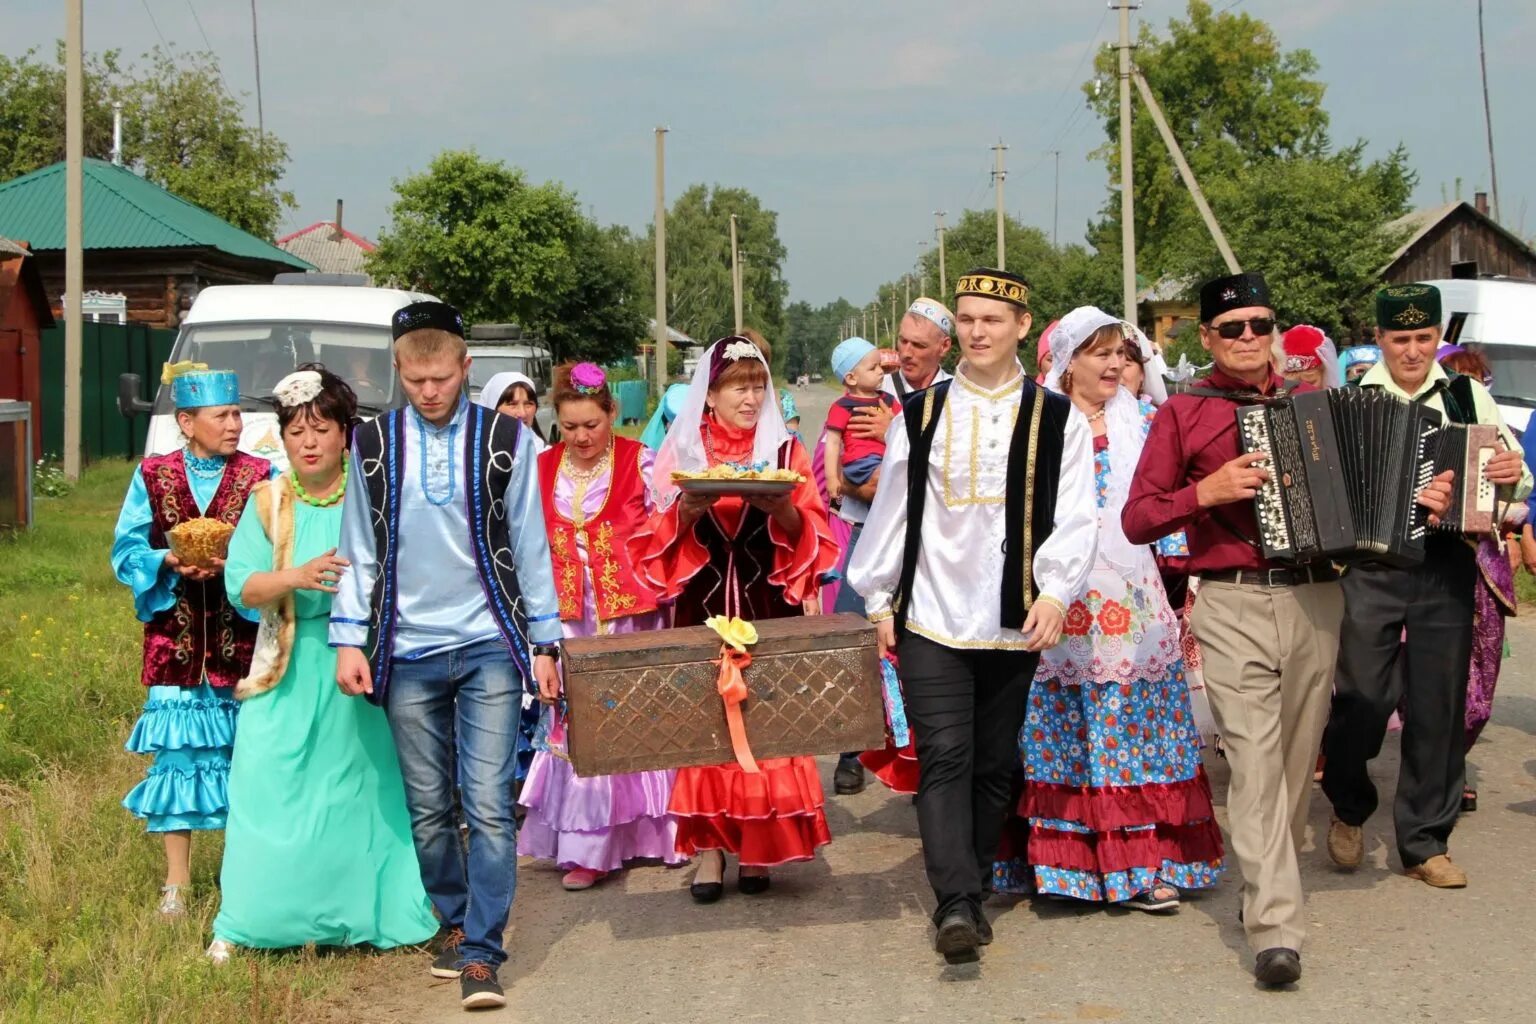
[0,462,390,1024]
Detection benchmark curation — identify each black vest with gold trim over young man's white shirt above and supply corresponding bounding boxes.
[894,379,1072,634]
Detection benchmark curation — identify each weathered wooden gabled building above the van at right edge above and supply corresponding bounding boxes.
[1379,192,1536,284]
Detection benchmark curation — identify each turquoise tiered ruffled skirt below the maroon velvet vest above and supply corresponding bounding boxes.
[123,683,240,832]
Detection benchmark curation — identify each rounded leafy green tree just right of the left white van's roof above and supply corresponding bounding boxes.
[367,150,645,362]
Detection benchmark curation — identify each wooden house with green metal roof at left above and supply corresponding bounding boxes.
[0,158,313,329]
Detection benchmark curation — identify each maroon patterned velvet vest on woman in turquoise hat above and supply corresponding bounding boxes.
[138,451,272,688]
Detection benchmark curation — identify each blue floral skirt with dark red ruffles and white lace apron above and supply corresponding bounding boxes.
[992,565,1223,903]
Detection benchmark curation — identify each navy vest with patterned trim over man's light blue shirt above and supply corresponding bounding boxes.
[349,404,533,705]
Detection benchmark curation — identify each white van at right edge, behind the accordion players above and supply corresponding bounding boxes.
[1424,278,1536,434]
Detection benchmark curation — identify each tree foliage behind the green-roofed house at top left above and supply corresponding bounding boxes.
[0,45,293,238]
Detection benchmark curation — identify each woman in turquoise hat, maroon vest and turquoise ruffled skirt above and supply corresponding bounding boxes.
[112,362,272,917]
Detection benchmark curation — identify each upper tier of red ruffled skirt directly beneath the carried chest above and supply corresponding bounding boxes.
[667,757,826,822]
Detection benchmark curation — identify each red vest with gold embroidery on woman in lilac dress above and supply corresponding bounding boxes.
[539,438,656,622]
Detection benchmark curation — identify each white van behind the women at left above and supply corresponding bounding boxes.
[118,284,432,468]
